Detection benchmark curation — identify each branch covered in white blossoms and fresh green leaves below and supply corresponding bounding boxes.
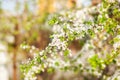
[21,0,120,80]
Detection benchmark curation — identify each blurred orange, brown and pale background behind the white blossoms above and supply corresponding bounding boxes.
[0,0,101,80]
